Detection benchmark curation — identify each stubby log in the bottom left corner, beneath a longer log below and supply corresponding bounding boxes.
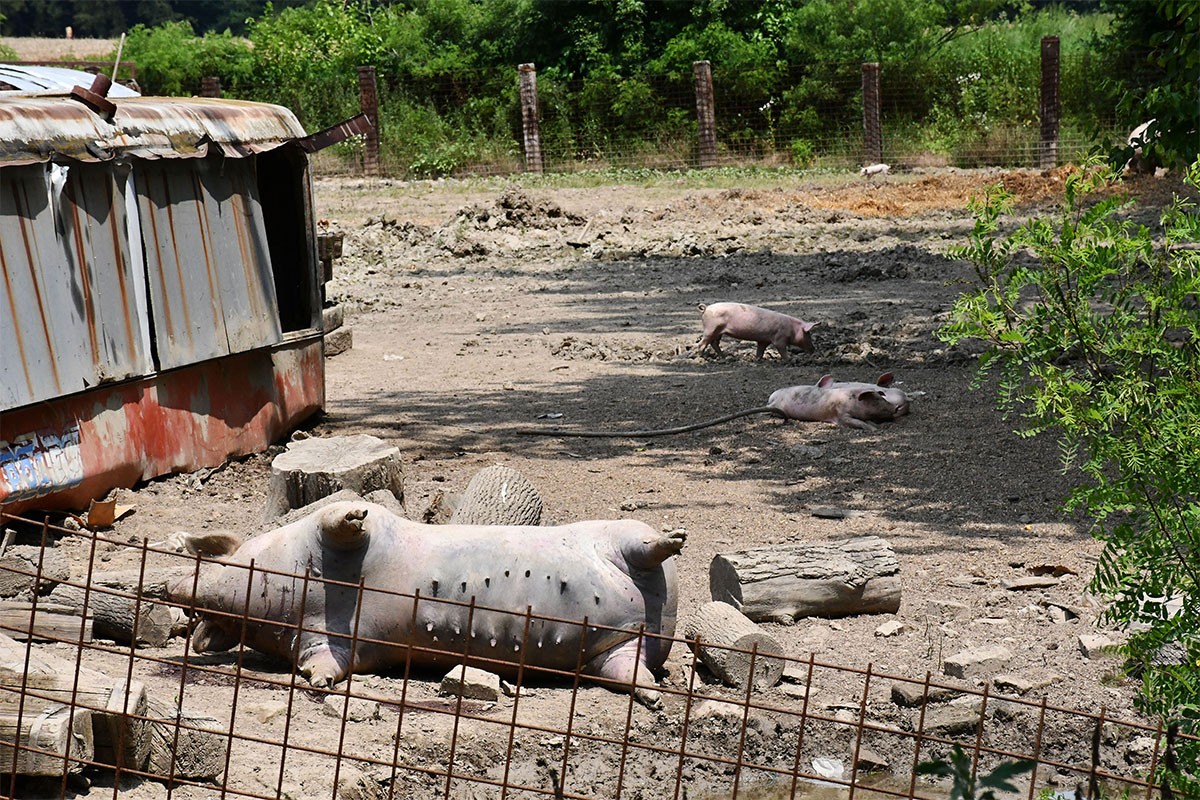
[0,705,95,776]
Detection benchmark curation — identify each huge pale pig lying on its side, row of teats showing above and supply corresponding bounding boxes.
[169,501,684,705]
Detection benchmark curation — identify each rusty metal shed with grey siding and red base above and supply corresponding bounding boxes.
[0,87,324,512]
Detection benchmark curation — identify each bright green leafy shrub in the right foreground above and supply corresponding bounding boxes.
[941,162,1200,796]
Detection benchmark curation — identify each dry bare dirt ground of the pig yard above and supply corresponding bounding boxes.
[11,172,1190,798]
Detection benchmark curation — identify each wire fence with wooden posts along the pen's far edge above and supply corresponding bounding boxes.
[318,46,1136,176]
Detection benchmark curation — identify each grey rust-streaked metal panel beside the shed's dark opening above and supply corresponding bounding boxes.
[137,158,282,369]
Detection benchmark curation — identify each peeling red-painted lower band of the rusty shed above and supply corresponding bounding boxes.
[0,336,325,513]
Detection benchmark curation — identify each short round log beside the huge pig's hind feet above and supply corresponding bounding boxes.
[683,600,785,690]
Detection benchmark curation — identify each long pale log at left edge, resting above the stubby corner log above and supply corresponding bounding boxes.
[0,636,149,771]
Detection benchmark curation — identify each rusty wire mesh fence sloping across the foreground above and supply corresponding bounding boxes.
[0,519,1190,800]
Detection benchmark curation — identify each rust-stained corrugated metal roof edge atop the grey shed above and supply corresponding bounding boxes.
[0,94,305,166]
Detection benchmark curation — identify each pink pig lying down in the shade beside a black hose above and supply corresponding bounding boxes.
[767,372,908,431]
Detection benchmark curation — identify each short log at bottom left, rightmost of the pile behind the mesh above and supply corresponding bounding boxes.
[146,698,229,780]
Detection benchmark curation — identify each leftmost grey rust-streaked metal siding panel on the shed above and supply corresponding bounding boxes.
[0,164,154,408]
